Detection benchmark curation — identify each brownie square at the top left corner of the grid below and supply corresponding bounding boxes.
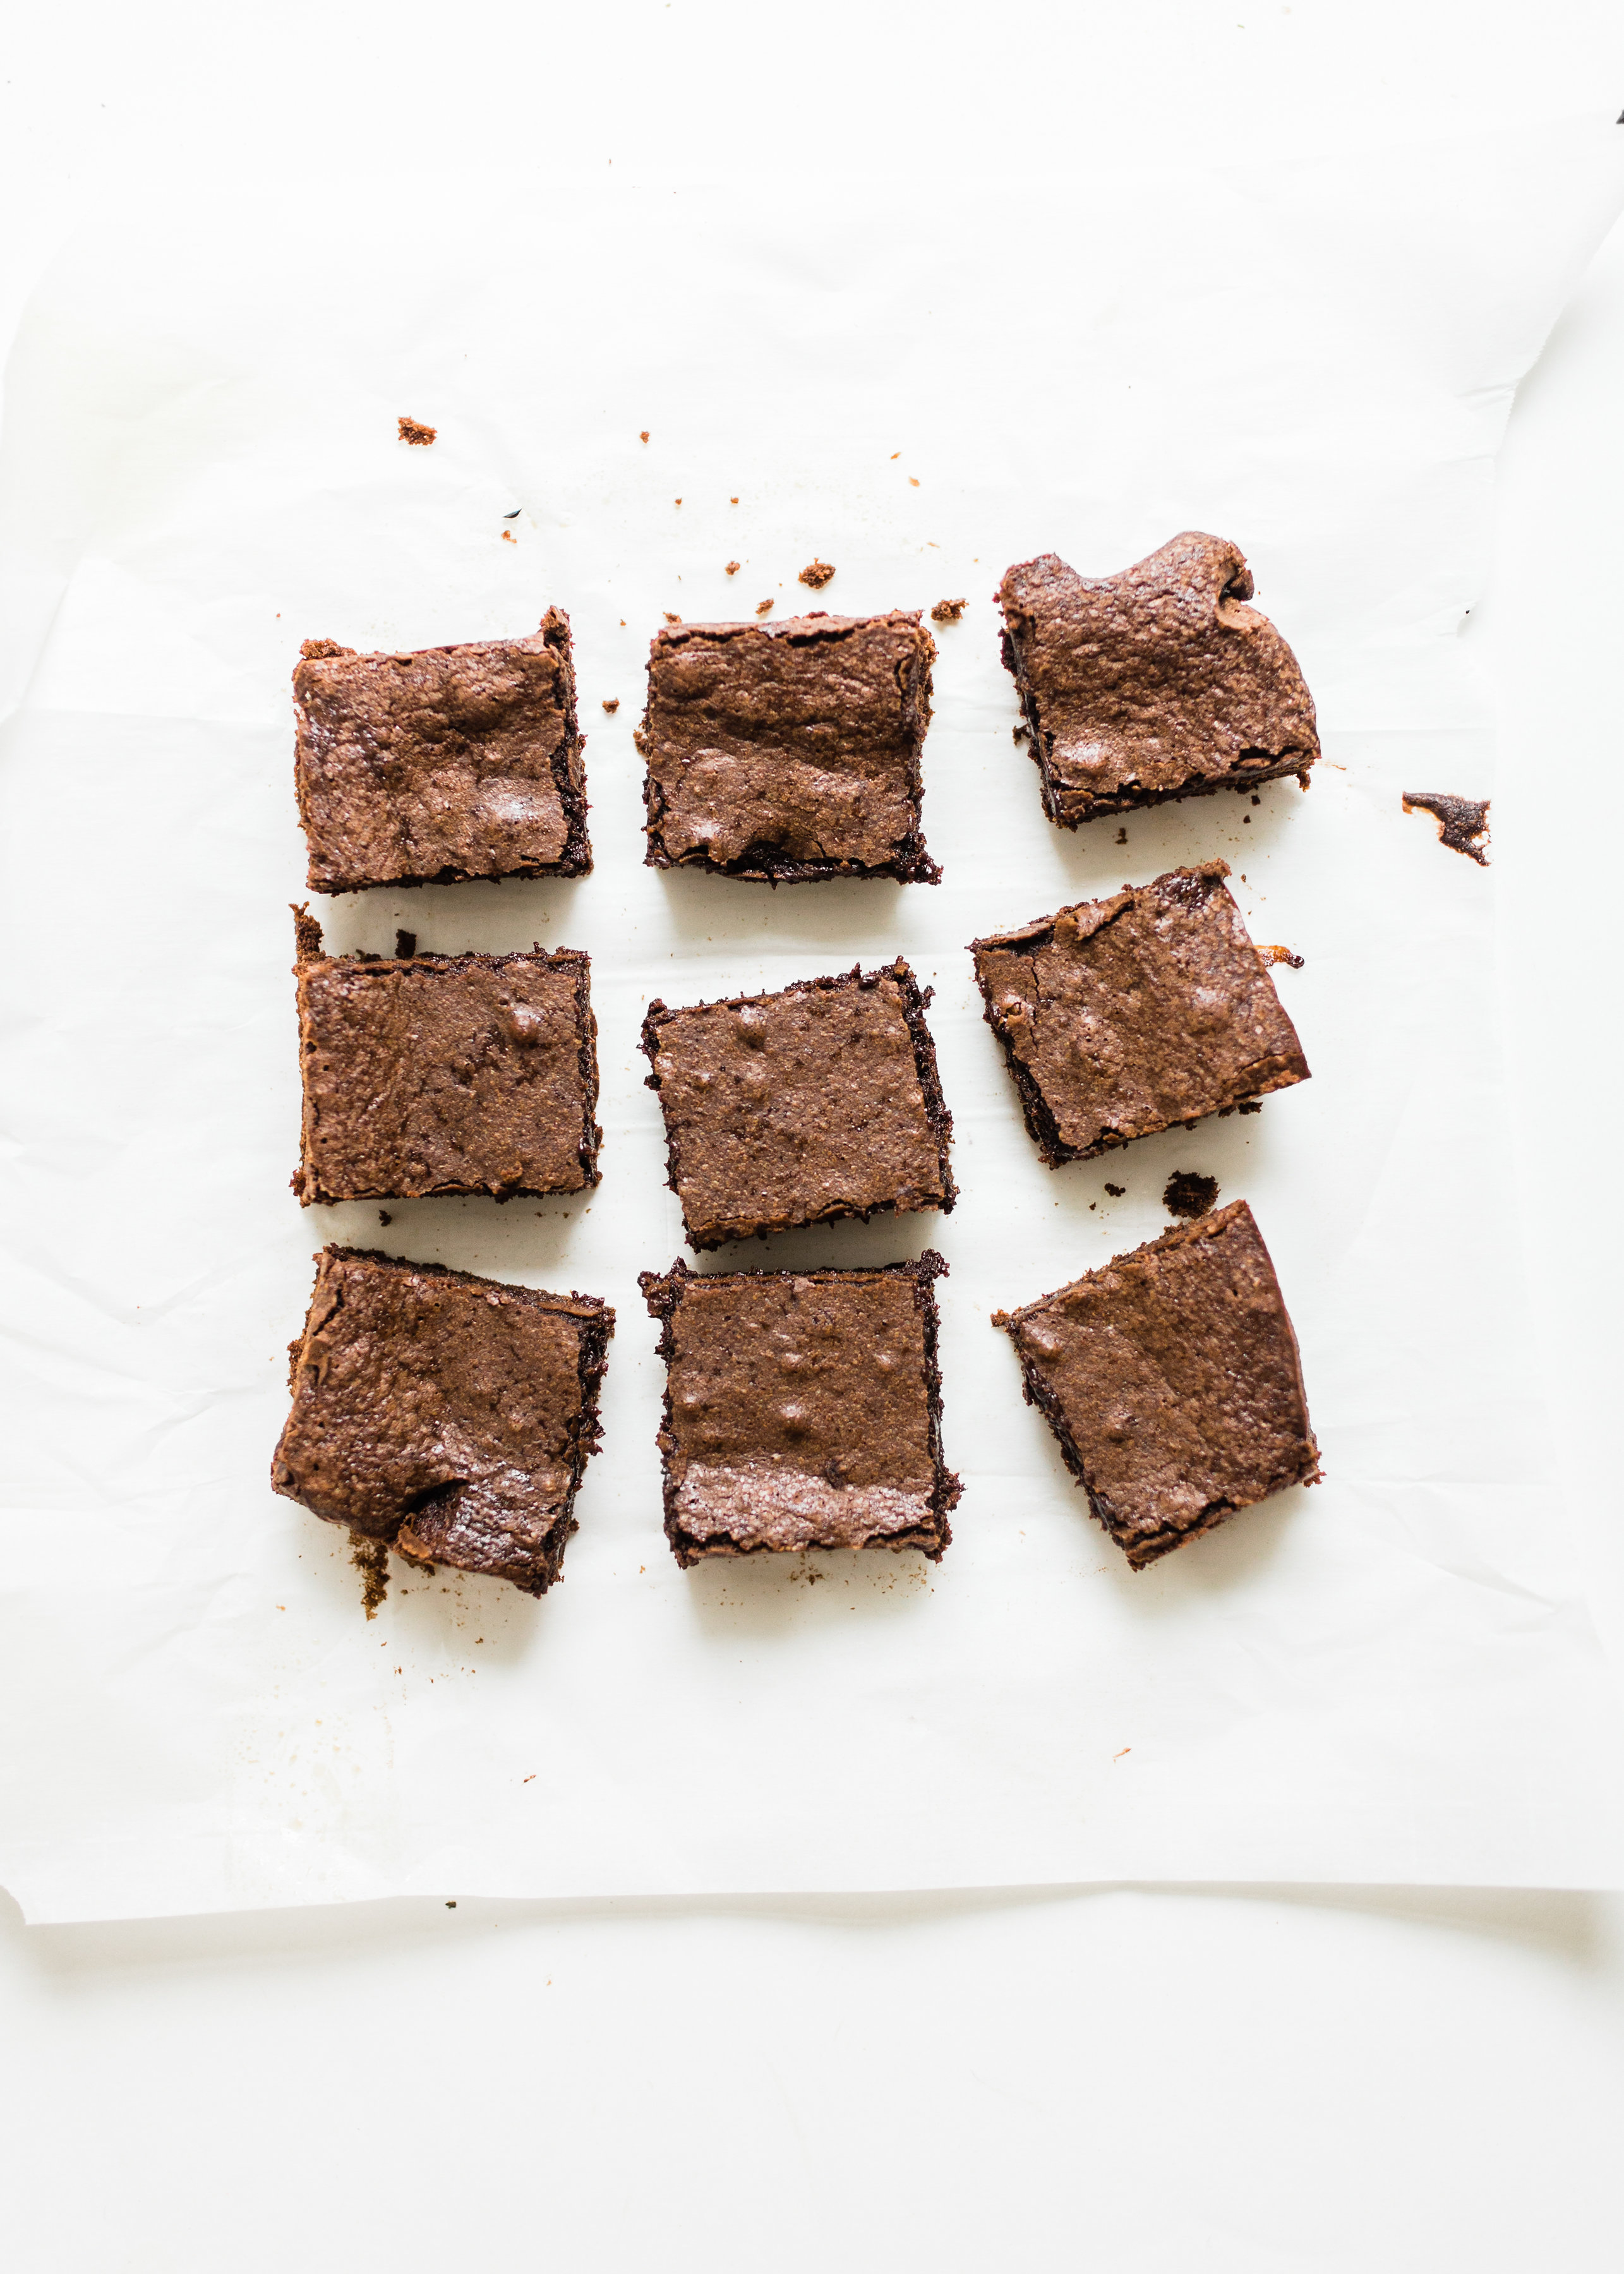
[294,607,591,891]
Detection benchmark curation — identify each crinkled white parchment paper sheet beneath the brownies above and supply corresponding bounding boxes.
[0,121,1624,1919]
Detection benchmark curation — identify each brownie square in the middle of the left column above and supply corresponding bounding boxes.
[294,914,603,1208]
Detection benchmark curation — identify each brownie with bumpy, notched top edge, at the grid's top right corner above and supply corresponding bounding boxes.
[999,530,1319,830]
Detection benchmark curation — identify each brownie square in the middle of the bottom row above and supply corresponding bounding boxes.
[641,1251,962,1567]
